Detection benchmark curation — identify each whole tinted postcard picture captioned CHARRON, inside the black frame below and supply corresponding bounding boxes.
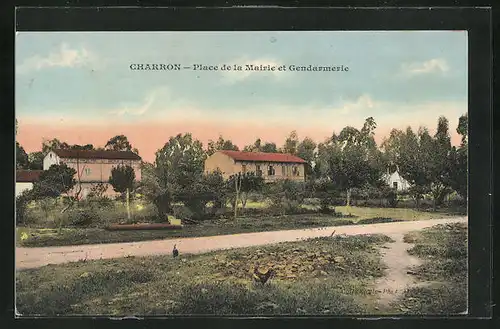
[15,31,468,317]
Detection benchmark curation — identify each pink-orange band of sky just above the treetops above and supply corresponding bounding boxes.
[17,122,460,162]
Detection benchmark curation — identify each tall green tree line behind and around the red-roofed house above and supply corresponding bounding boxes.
[15,114,468,223]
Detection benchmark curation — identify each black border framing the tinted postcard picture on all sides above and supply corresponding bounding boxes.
[1,1,493,327]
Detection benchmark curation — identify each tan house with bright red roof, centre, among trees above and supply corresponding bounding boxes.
[205,151,307,182]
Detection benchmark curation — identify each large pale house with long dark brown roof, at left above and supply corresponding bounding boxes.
[43,150,141,198]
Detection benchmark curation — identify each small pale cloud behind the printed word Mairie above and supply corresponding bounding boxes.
[221,58,284,84]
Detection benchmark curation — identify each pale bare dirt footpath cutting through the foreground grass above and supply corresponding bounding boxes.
[375,234,422,311]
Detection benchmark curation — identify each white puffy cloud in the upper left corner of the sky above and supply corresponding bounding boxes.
[16,43,97,74]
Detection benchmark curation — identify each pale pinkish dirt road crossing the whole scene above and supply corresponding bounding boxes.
[16,217,467,270]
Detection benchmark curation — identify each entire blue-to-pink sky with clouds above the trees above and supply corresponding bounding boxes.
[15,31,467,161]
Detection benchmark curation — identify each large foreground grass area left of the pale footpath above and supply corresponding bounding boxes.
[16,235,390,316]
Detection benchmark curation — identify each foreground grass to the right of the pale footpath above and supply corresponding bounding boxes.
[397,224,467,315]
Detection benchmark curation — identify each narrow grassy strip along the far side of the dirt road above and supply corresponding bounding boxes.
[17,203,458,247]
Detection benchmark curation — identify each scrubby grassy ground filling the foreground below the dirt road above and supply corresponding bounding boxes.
[16,221,467,316]
